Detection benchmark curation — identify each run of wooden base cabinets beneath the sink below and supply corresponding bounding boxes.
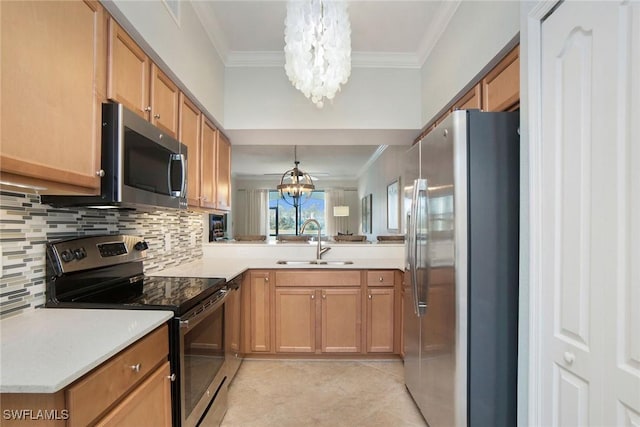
[243,269,402,355]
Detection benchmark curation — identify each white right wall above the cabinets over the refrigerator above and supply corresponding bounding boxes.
[421,1,520,127]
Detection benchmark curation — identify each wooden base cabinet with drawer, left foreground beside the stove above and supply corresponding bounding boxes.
[0,325,171,427]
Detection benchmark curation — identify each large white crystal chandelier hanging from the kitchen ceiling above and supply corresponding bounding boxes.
[284,0,351,108]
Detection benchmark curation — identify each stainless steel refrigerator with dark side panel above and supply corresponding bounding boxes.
[402,110,519,427]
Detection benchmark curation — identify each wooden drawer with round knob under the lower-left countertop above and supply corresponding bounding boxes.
[66,325,169,427]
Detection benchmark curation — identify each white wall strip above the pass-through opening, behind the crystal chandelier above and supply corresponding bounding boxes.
[224,67,421,129]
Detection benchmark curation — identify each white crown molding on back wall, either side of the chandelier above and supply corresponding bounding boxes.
[225,51,421,69]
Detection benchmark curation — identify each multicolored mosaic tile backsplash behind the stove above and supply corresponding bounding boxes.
[0,191,204,318]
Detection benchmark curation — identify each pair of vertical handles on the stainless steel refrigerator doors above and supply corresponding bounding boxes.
[412,179,429,317]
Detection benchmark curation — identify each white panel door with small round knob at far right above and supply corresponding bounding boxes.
[539,1,640,427]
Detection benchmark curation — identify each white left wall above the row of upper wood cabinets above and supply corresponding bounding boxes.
[103,0,225,124]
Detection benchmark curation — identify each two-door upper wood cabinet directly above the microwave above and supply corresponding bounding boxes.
[107,18,180,138]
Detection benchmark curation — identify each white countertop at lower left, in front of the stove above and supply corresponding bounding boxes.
[0,308,173,393]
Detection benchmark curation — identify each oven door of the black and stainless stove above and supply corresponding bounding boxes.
[180,290,227,427]
